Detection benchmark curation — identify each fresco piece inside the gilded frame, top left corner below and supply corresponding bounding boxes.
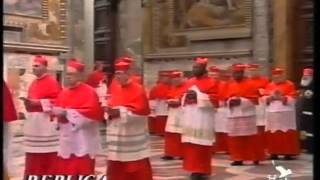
[3,0,42,17]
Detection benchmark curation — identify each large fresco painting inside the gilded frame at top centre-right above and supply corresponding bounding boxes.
[174,0,247,30]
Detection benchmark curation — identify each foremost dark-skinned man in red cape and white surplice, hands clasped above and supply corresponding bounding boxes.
[181,58,218,179]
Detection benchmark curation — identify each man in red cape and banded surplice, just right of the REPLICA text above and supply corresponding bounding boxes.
[106,62,152,180]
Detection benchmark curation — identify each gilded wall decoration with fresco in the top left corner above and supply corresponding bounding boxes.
[4,0,66,44]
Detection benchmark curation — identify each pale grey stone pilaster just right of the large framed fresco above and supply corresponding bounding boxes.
[252,0,271,74]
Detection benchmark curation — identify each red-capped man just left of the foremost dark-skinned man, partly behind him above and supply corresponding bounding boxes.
[162,71,186,160]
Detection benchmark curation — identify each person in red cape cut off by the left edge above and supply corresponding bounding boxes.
[2,80,18,180]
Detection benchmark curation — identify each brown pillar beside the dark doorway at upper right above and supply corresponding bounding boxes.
[272,0,295,77]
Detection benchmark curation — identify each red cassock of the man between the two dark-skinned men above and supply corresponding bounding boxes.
[213,81,228,153]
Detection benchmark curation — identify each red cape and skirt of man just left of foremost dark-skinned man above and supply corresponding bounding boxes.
[164,84,186,157]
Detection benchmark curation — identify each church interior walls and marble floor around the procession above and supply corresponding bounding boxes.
[3,0,314,180]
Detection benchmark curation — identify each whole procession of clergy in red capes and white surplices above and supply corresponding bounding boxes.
[4,56,313,180]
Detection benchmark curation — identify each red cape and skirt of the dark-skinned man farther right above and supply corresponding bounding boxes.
[227,79,265,161]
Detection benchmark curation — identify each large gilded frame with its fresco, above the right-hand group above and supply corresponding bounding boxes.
[145,0,253,54]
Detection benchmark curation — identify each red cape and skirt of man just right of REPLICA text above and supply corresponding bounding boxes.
[107,82,152,180]
